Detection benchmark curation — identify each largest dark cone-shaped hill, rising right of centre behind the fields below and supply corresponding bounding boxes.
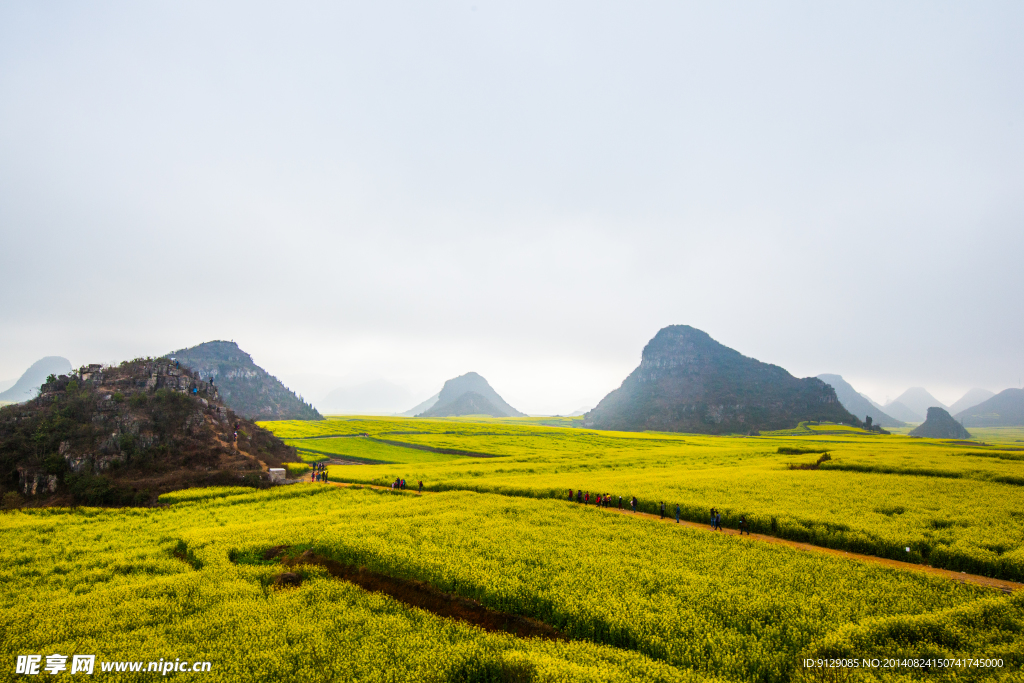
[584,325,861,434]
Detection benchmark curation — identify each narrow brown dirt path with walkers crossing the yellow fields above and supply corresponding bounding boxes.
[321,481,1024,593]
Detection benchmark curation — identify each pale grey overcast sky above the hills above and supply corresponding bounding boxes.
[0,0,1024,413]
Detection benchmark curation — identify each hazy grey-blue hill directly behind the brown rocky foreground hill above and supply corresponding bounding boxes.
[167,341,324,421]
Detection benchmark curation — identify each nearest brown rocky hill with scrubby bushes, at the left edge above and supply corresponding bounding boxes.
[0,359,298,505]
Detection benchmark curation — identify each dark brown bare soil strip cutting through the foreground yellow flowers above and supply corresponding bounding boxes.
[276,546,568,640]
